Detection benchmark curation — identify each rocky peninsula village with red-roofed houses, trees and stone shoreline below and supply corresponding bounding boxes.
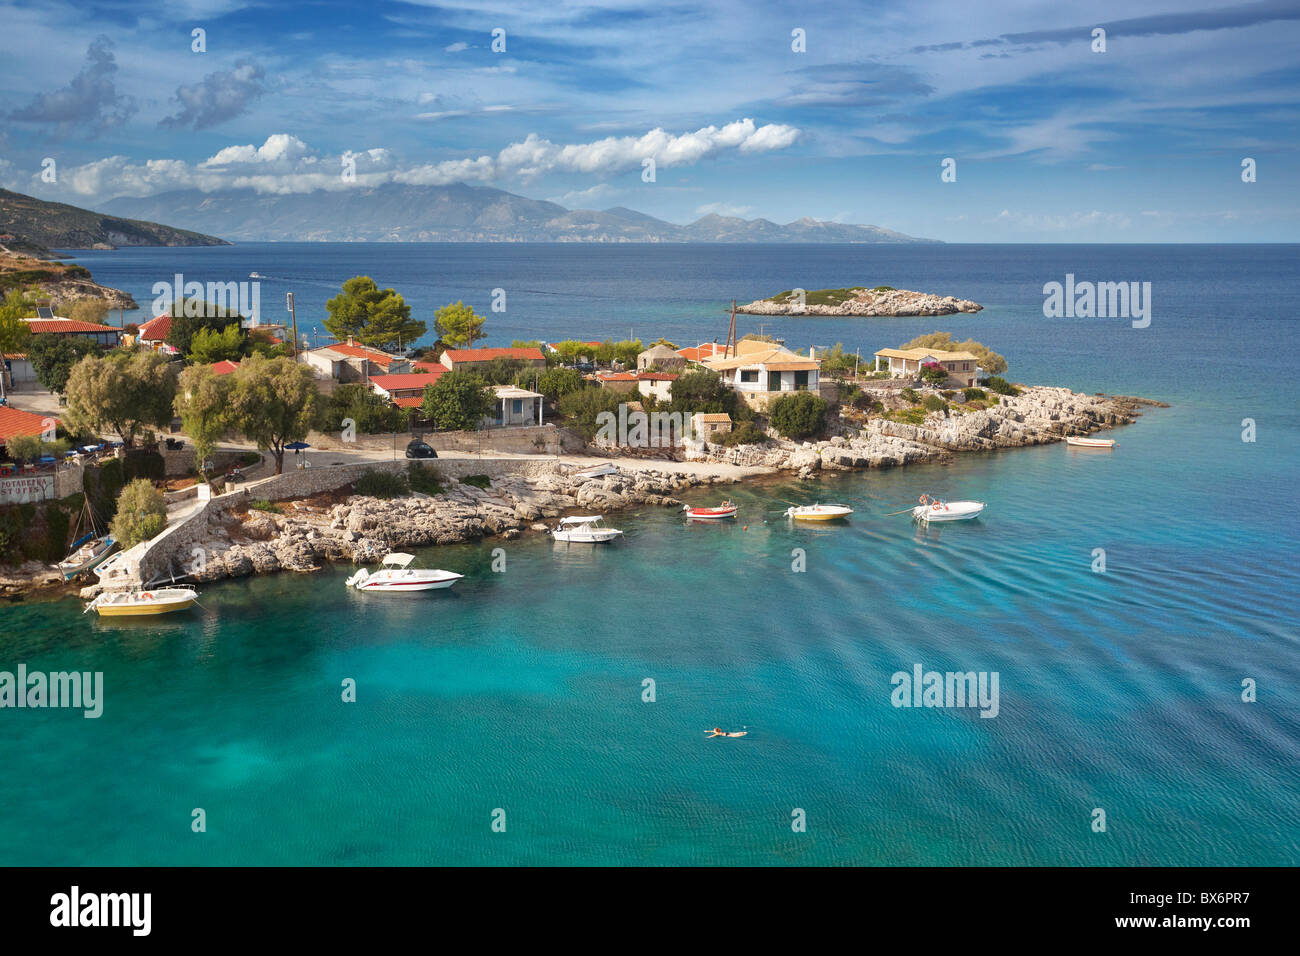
[0,277,1138,597]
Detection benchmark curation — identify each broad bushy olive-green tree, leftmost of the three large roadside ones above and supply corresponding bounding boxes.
[65,350,177,447]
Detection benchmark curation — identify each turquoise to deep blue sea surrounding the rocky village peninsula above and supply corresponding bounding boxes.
[0,243,1300,865]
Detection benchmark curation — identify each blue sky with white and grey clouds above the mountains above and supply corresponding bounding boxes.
[0,0,1300,242]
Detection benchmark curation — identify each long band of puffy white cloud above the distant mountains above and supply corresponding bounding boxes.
[43,121,800,198]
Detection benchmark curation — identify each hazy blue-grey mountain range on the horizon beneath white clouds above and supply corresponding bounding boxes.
[104,183,933,242]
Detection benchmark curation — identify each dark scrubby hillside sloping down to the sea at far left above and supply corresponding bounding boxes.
[0,189,230,254]
